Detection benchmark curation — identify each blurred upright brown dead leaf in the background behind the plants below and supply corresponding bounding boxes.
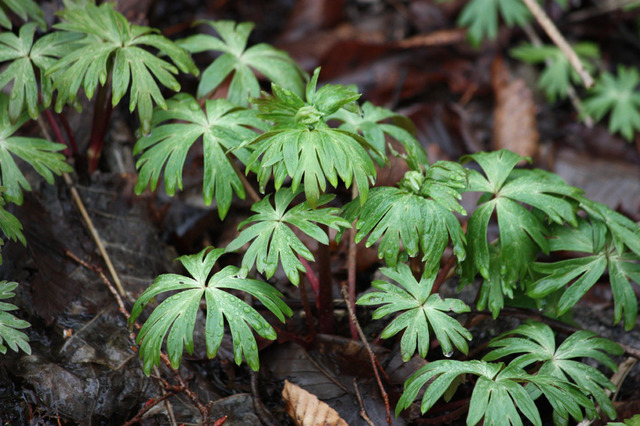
[491,57,539,157]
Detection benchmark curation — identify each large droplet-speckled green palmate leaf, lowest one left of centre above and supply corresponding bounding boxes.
[129,248,292,374]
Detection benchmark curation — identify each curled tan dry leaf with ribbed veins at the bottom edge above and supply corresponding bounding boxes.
[282,380,348,426]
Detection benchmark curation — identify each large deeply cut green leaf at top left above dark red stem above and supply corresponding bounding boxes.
[47,3,199,134]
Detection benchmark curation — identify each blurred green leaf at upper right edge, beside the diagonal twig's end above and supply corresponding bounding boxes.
[582,66,640,141]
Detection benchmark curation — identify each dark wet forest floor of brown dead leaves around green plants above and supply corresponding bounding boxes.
[0,0,640,425]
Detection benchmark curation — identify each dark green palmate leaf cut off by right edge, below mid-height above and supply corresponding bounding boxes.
[527,220,640,330]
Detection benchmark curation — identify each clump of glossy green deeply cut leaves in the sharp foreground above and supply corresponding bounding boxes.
[0,0,640,425]
